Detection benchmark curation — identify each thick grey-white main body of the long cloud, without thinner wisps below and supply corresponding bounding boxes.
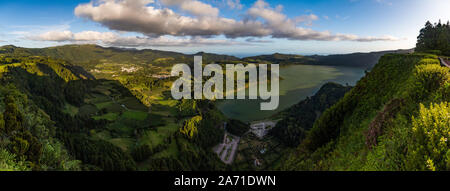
[75,0,270,37]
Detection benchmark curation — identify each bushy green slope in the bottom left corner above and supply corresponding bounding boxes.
[0,85,81,170]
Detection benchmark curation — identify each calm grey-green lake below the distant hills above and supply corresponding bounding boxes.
[217,65,364,122]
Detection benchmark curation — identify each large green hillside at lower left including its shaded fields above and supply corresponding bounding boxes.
[0,55,225,171]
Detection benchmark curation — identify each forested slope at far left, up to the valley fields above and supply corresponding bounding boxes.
[0,56,96,170]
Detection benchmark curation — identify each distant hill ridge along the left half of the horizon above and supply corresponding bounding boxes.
[0,44,239,68]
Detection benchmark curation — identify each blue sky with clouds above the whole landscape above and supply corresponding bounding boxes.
[0,0,450,57]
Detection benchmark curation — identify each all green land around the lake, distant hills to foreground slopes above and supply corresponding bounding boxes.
[0,22,450,171]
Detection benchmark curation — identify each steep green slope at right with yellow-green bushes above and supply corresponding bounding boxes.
[283,53,450,171]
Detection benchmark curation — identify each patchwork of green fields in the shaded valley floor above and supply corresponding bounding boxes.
[64,78,213,170]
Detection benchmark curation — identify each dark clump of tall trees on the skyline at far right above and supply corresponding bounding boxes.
[416,21,450,56]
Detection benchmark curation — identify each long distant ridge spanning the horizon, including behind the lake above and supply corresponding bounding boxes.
[0,45,413,71]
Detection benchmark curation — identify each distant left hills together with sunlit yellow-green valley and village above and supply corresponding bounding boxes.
[0,45,244,106]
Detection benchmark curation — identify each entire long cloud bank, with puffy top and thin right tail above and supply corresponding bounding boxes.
[68,0,402,42]
